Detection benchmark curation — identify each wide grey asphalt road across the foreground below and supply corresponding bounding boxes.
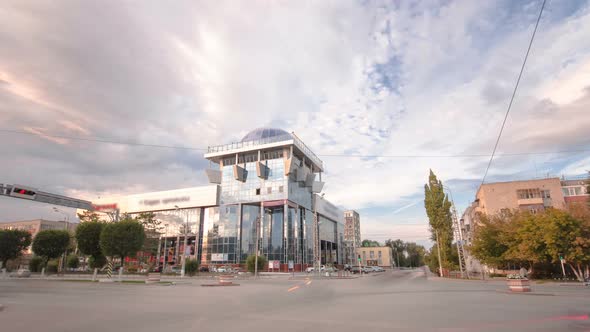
[0,270,590,332]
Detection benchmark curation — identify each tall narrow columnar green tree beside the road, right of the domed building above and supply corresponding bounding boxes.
[424,170,458,268]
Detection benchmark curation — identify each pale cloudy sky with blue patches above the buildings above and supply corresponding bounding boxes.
[0,0,590,249]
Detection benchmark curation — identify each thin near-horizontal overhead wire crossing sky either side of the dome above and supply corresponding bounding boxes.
[0,129,590,159]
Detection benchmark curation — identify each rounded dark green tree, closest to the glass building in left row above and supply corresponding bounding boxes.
[100,217,145,265]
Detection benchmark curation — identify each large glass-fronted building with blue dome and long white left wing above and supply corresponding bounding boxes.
[88,128,345,271]
